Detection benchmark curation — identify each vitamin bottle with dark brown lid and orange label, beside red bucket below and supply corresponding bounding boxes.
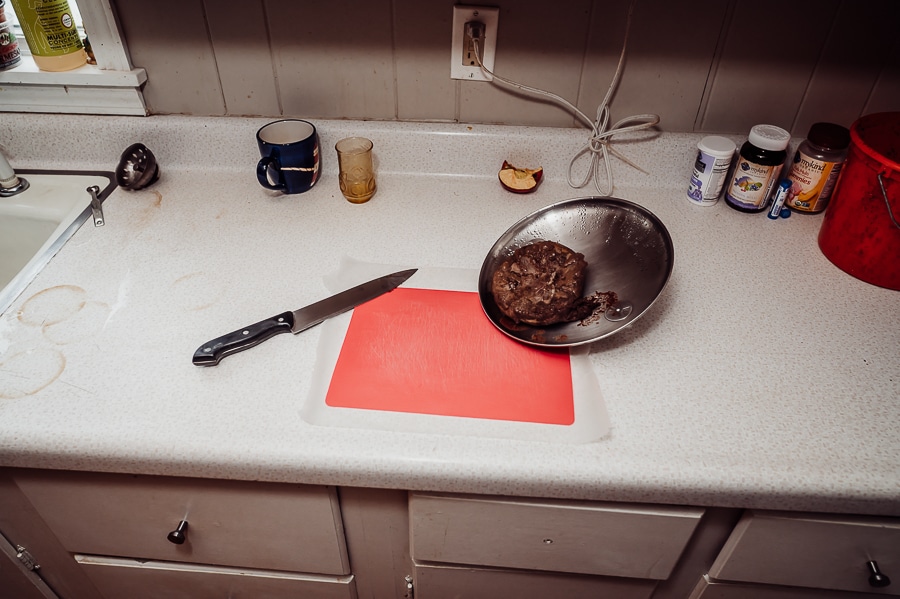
[786,123,850,214]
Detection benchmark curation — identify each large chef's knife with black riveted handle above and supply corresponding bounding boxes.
[193,268,417,366]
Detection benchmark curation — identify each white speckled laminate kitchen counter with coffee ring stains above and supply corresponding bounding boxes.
[0,114,900,516]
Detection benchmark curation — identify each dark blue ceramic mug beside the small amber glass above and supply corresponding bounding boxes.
[256,119,322,193]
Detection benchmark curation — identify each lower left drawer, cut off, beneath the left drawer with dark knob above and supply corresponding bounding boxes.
[75,555,356,599]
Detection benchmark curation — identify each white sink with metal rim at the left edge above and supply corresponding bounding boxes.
[0,170,116,314]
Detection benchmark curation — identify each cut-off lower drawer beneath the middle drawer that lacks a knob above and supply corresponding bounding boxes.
[413,564,657,599]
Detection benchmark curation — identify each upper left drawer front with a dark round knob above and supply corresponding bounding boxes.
[15,471,349,574]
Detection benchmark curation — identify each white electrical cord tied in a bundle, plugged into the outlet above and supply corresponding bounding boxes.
[474,0,659,195]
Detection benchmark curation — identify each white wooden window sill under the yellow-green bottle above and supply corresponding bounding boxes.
[0,56,147,116]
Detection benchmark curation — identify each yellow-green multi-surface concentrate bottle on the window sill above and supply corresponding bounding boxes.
[11,0,87,71]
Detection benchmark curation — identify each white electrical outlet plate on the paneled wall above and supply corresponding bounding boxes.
[450,6,500,81]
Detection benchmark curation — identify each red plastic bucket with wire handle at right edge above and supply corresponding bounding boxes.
[819,112,900,290]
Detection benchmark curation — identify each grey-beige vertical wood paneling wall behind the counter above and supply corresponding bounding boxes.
[116,0,900,136]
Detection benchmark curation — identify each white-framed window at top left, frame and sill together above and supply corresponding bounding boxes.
[0,0,147,115]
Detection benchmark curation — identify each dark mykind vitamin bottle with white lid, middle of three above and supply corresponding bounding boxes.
[725,125,791,212]
